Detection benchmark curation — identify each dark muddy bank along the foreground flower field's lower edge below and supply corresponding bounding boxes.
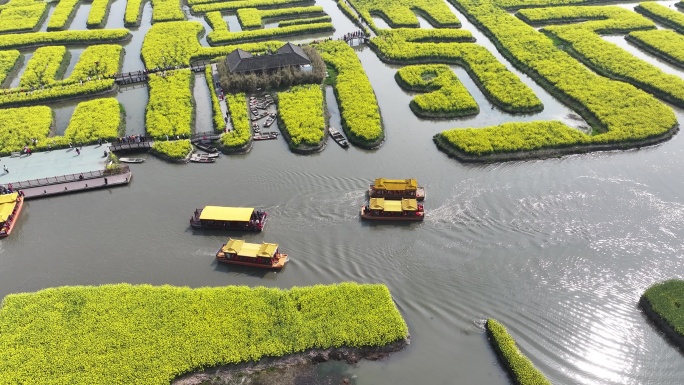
[172,336,411,385]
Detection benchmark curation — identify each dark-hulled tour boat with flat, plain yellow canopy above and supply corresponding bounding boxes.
[190,206,268,231]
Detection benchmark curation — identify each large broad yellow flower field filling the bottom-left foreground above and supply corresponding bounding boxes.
[0,280,408,385]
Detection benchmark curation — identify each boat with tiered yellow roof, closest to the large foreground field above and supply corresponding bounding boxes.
[216,239,289,269]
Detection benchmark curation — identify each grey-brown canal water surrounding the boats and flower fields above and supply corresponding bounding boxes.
[0,1,684,385]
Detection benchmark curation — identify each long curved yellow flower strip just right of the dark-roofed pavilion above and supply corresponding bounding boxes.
[315,40,385,148]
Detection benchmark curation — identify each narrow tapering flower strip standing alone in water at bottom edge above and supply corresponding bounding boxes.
[485,318,551,385]
